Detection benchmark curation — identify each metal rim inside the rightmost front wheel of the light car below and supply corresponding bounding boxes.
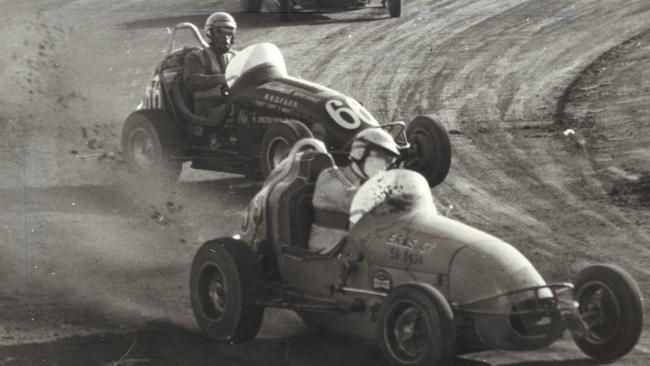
[576,281,622,344]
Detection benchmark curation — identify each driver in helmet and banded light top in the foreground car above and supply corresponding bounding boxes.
[309,128,400,254]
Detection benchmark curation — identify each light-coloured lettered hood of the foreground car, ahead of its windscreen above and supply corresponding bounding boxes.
[350,204,545,305]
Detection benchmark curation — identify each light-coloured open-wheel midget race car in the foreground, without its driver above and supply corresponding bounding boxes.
[190,139,644,366]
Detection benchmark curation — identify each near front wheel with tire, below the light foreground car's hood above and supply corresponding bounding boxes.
[379,284,455,366]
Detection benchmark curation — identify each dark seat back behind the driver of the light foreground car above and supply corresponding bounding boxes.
[278,151,334,249]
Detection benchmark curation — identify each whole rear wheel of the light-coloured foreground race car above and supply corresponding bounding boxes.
[190,238,264,343]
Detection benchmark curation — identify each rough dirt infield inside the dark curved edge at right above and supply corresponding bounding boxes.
[558,28,650,210]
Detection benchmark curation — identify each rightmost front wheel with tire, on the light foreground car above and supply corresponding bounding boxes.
[572,264,643,362]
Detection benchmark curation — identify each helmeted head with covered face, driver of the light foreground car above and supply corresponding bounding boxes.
[350,128,399,180]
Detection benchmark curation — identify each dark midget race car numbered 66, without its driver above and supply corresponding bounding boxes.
[121,23,451,186]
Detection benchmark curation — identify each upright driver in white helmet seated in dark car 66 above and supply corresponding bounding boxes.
[183,12,237,122]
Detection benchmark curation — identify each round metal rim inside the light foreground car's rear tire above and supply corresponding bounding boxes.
[198,265,228,320]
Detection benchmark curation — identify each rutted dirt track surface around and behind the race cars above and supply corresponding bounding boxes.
[0,0,650,366]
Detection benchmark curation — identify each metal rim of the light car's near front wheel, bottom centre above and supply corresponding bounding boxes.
[384,300,433,363]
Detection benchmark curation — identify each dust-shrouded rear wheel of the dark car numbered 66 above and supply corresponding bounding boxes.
[122,109,183,182]
